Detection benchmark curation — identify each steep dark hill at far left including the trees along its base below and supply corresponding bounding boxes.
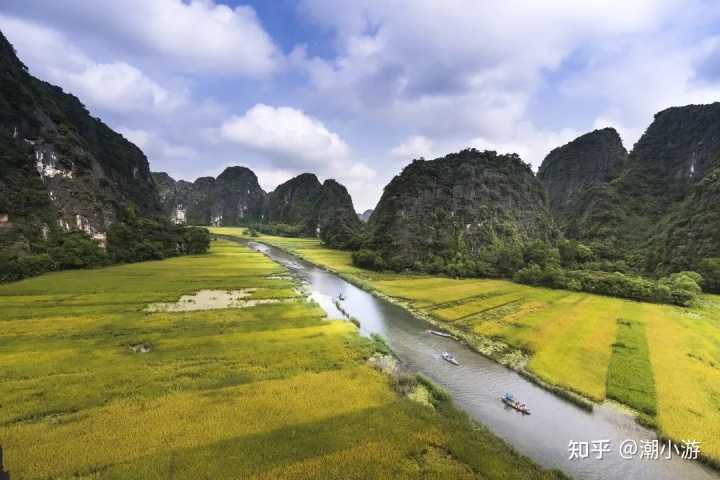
[0,29,210,281]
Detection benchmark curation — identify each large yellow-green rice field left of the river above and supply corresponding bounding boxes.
[0,241,559,480]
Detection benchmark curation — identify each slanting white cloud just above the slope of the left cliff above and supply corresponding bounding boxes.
[0,15,188,113]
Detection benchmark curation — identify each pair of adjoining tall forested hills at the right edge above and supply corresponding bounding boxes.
[539,103,720,290]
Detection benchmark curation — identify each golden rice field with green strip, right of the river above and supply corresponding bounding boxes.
[214,231,720,461]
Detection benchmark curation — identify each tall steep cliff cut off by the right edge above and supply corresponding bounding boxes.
[632,103,720,274]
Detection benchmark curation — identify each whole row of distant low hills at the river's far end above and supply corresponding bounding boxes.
[153,171,364,248]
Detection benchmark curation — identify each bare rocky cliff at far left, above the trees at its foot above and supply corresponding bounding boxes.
[0,33,161,249]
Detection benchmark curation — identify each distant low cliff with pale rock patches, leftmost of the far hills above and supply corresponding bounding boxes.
[152,166,266,226]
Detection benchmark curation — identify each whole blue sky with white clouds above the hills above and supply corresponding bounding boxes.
[0,0,720,211]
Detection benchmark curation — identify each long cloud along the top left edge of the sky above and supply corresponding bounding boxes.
[4,0,283,77]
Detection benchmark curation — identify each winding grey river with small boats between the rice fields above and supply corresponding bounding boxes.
[249,242,720,480]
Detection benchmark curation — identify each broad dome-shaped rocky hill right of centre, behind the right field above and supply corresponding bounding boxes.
[365,149,556,265]
